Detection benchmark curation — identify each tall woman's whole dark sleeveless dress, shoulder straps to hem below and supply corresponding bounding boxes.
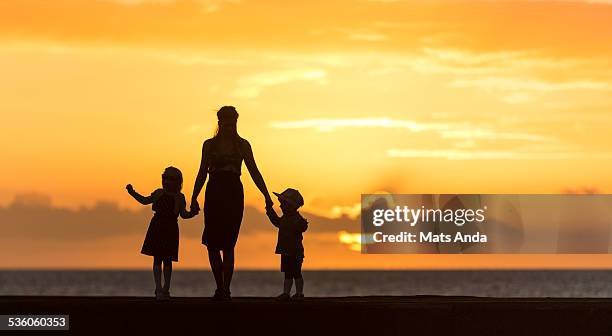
[202,138,244,250]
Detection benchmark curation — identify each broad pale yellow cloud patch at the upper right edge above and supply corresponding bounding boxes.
[412,48,612,104]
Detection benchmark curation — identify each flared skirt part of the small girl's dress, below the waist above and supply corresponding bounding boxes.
[140,215,179,261]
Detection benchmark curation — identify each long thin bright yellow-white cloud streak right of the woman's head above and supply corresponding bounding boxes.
[270,118,557,142]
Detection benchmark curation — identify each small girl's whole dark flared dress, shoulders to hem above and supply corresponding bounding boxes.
[140,193,179,261]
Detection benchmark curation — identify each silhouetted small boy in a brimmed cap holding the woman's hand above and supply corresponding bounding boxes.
[266,188,308,301]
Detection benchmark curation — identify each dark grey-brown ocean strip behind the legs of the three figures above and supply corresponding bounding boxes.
[0,270,612,297]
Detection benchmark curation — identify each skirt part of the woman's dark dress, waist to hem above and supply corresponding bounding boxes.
[202,171,244,250]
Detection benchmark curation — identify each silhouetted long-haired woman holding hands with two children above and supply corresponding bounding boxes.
[191,106,272,300]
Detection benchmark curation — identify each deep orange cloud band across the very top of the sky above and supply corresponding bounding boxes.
[0,0,612,55]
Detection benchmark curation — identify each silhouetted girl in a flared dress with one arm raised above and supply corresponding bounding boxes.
[126,167,198,300]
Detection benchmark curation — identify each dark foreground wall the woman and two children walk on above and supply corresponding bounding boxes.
[0,296,612,336]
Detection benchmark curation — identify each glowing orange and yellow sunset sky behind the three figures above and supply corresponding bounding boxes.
[0,0,612,268]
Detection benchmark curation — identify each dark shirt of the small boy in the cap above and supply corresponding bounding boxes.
[266,208,308,258]
